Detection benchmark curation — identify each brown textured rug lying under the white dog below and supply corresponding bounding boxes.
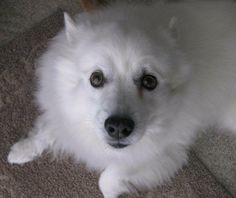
[0,11,232,198]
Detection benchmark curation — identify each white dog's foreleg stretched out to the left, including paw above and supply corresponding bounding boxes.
[8,116,53,164]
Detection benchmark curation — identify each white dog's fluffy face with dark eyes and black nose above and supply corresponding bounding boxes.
[42,13,190,148]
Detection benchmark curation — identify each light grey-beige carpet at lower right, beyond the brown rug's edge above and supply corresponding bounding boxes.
[193,129,236,197]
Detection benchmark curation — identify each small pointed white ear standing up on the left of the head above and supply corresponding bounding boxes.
[64,12,77,42]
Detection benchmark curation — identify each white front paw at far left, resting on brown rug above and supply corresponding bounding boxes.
[7,139,37,164]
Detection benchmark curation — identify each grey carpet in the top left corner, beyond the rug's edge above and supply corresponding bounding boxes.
[0,0,81,46]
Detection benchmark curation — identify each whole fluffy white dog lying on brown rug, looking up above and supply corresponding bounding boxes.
[8,2,236,198]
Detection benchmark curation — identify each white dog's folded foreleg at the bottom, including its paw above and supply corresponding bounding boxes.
[99,146,187,198]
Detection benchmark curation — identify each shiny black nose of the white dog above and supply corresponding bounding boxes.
[104,116,134,140]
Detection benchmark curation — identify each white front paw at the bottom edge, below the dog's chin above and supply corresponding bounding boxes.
[99,169,129,198]
